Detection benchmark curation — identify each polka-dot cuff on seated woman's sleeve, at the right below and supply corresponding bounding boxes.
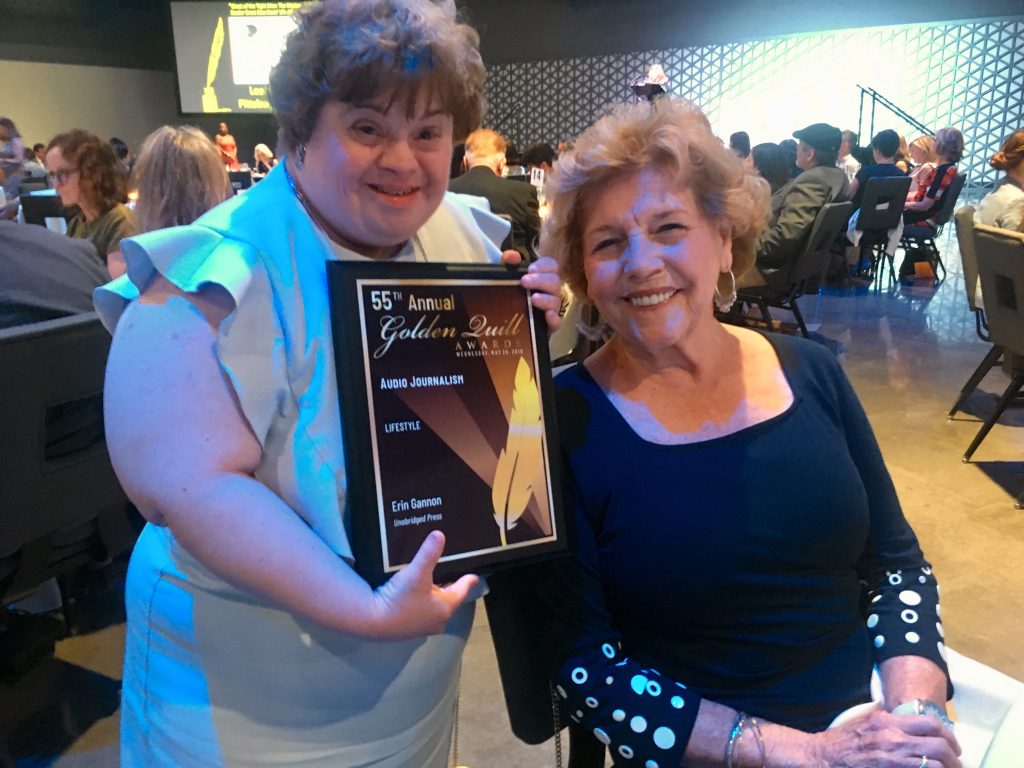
[867,564,946,670]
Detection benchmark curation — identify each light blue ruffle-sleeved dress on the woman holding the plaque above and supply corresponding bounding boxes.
[95,166,507,768]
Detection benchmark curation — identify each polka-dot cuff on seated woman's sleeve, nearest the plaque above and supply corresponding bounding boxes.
[555,643,700,768]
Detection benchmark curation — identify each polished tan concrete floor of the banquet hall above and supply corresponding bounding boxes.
[0,221,1024,768]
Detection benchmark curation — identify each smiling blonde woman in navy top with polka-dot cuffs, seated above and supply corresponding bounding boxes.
[492,98,961,768]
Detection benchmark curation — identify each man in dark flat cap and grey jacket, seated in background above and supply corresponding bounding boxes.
[736,123,850,291]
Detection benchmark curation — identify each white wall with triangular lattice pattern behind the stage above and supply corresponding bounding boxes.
[484,17,1024,185]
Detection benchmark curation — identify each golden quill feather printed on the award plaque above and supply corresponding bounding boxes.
[490,357,543,547]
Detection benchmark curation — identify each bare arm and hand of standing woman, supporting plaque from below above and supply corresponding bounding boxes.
[104,278,476,639]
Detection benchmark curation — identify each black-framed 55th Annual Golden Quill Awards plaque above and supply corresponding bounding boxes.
[327,261,568,586]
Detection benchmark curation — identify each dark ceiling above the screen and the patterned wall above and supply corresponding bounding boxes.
[0,0,1024,72]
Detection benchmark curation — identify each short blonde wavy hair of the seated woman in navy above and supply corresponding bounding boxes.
[540,98,770,307]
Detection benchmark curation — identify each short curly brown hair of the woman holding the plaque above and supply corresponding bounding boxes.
[269,0,484,150]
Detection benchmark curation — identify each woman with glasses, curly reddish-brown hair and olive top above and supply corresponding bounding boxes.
[46,130,136,276]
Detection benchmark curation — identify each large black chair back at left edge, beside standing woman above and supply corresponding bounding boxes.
[0,312,133,604]
